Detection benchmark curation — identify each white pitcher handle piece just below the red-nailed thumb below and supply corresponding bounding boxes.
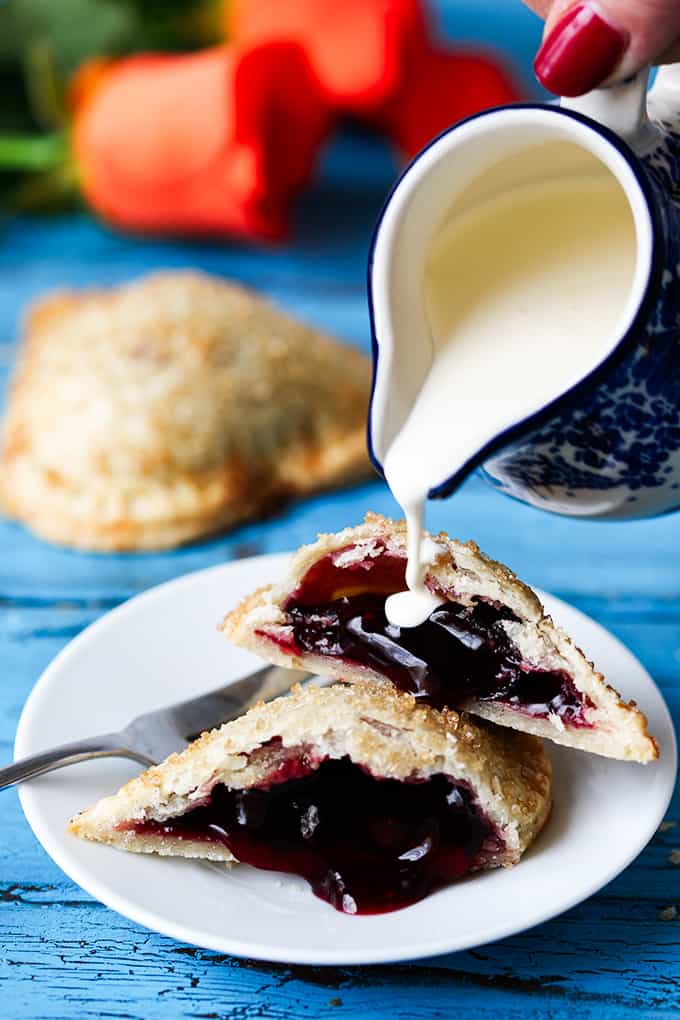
[561,67,650,149]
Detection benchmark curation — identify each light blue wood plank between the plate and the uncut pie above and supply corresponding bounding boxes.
[0,477,680,605]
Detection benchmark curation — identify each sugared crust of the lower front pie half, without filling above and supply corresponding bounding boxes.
[69,682,551,867]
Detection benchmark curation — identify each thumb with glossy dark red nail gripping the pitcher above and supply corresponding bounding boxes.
[531,0,680,96]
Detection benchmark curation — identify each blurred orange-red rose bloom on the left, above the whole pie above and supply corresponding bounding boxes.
[73,44,329,240]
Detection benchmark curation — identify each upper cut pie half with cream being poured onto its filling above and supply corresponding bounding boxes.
[223,514,659,762]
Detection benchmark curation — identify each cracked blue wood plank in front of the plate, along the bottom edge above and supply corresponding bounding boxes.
[0,873,680,1020]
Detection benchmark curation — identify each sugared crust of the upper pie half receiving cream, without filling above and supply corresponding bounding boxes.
[222,513,659,762]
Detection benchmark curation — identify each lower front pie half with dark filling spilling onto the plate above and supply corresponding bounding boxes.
[69,683,551,914]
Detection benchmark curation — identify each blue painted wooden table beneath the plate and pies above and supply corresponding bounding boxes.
[0,0,680,1020]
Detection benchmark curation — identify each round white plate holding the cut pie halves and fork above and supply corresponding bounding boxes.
[15,556,676,964]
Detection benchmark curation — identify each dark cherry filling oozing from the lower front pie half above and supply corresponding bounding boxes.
[127,758,497,914]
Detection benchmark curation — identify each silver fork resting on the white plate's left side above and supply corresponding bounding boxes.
[0,666,310,789]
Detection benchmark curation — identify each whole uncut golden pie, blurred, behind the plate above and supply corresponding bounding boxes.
[0,272,370,550]
